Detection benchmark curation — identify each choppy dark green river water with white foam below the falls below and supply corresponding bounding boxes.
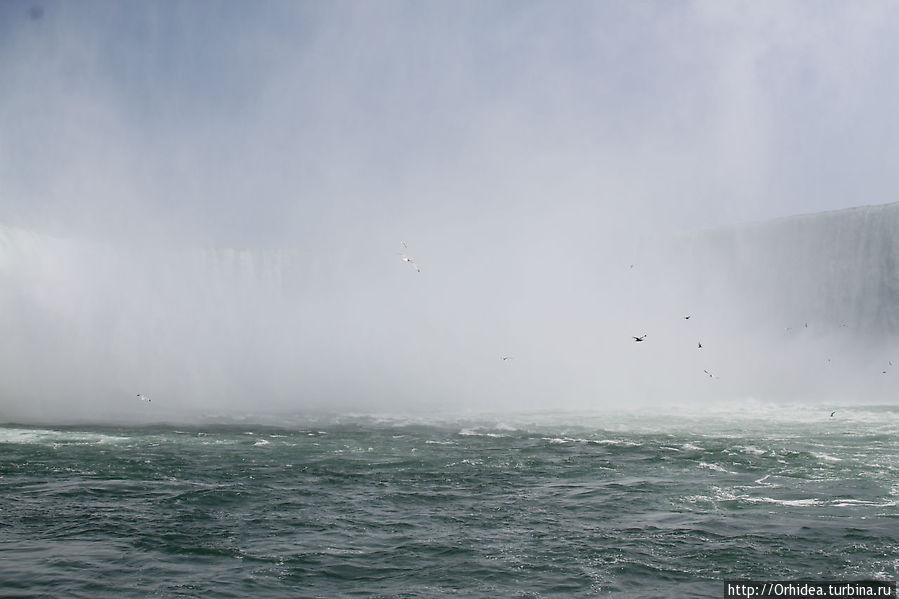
[0,406,899,597]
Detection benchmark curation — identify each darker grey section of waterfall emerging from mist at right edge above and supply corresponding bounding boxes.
[675,203,899,341]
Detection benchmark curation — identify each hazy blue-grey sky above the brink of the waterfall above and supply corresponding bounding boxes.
[0,0,899,247]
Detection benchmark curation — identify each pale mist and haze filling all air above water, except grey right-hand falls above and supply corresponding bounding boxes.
[0,1,899,421]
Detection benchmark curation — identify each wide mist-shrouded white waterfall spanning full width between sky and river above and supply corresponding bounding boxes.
[0,204,899,420]
